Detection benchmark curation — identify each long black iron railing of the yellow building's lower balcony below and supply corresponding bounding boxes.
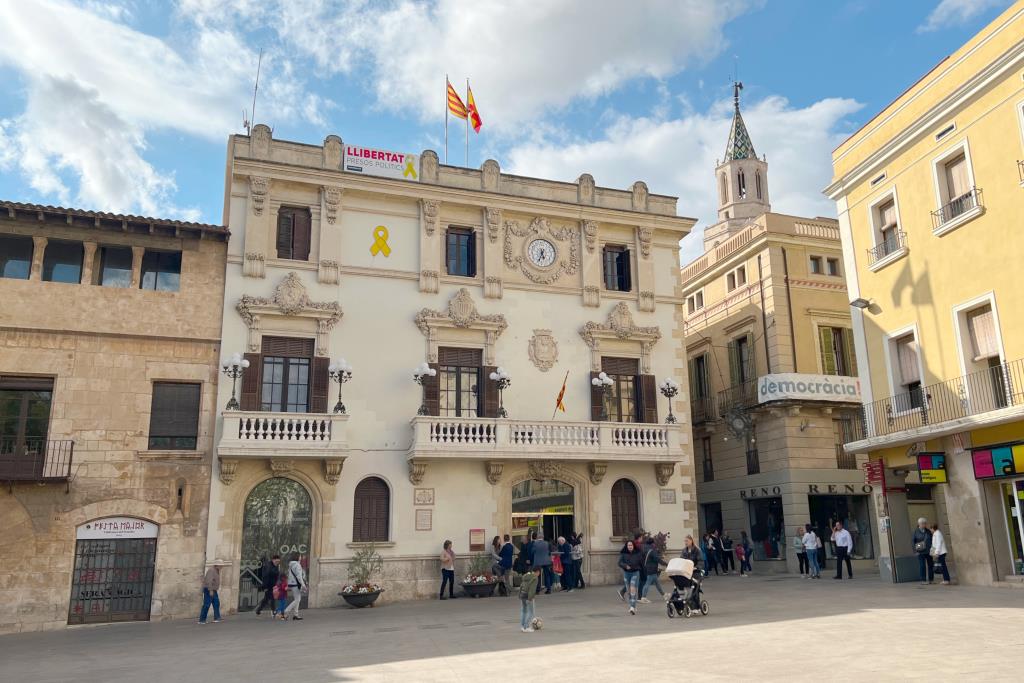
[853,358,1024,440]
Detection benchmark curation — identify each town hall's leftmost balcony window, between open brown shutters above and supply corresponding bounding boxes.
[260,337,313,413]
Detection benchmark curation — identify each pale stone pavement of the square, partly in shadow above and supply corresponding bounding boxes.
[0,575,1024,683]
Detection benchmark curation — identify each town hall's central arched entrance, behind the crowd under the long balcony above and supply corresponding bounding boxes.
[512,479,577,545]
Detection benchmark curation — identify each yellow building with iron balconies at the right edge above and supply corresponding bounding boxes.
[825,2,1024,584]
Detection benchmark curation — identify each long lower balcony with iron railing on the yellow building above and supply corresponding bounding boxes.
[846,359,1024,453]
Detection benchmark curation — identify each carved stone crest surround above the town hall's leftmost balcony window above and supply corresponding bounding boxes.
[234,271,344,355]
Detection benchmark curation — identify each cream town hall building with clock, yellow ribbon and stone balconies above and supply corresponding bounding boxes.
[201,125,695,610]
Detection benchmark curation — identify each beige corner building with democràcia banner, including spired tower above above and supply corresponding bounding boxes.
[682,84,877,571]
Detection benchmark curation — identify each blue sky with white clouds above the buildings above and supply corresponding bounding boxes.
[0,0,1011,263]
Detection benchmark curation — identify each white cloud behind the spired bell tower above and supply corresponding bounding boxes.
[505,97,861,263]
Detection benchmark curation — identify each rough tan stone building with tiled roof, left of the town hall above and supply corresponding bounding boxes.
[0,202,227,632]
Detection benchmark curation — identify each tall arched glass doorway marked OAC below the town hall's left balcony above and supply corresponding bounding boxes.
[239,477,313,611]
